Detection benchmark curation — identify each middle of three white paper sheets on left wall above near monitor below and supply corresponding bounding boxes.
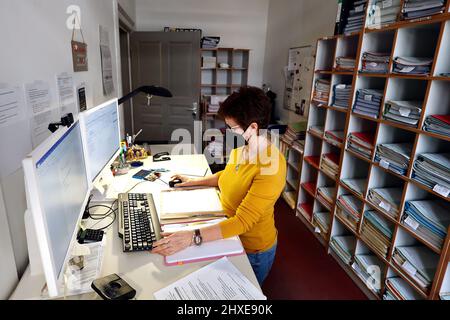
[25,81,56,148]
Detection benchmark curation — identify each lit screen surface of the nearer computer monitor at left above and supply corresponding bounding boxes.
[36,122,89,278]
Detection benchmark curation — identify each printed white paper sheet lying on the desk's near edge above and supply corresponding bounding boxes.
[155,258,267,301]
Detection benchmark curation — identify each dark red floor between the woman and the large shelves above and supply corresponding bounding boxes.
[263,200,367,300]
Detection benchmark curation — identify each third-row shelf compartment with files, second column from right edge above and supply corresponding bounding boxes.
[375,124,416,177]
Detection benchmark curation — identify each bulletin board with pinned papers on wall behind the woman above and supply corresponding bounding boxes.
[284,46,315,117]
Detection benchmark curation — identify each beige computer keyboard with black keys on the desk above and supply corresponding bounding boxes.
[118,193,161,252]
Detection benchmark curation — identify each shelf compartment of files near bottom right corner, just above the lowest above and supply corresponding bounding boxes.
[392,228,439,296]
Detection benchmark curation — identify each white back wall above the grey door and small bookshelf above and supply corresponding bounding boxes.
[136,0,269,86]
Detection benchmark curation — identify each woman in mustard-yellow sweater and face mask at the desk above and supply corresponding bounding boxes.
[153,87,286,284]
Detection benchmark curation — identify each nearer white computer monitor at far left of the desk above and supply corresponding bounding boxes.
[23,122,90,297]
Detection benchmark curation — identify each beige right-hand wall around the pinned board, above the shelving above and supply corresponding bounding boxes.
[264,0,337,122]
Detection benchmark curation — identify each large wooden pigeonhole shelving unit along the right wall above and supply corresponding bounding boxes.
[297,2,450,300]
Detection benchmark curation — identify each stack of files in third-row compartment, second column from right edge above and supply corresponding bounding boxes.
[375,143,413,176]
